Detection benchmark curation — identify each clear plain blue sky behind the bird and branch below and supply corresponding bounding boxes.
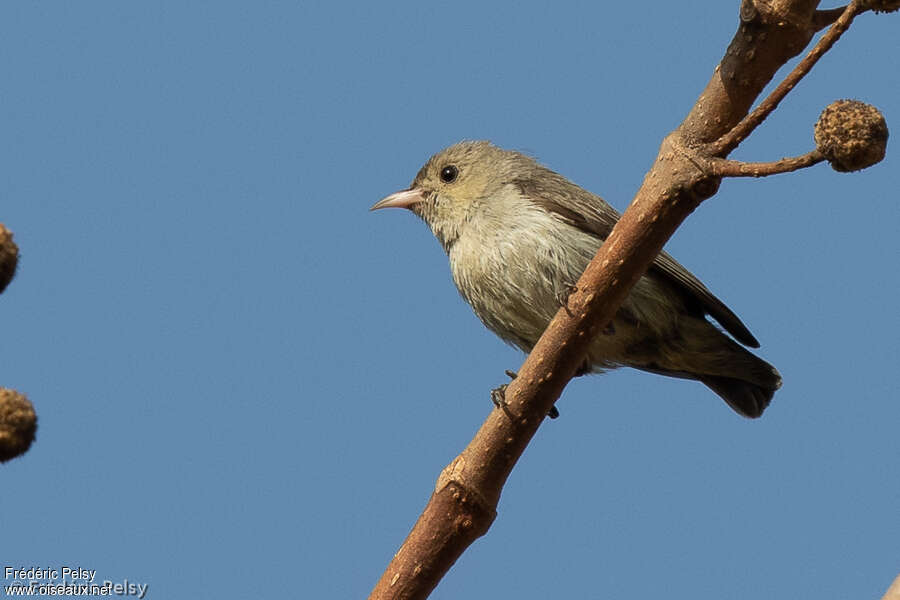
[0,0,900,599]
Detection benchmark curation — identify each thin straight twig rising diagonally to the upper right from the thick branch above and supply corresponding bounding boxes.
[709,0,864,157]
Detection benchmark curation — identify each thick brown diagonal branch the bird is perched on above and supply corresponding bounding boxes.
[370,0,888,599]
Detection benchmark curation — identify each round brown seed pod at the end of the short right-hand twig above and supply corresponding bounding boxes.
[815,100,888,172]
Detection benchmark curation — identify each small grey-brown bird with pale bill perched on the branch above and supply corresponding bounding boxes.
[372,141,781,417]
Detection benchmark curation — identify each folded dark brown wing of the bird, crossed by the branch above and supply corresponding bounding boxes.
[516,171,759,348]
